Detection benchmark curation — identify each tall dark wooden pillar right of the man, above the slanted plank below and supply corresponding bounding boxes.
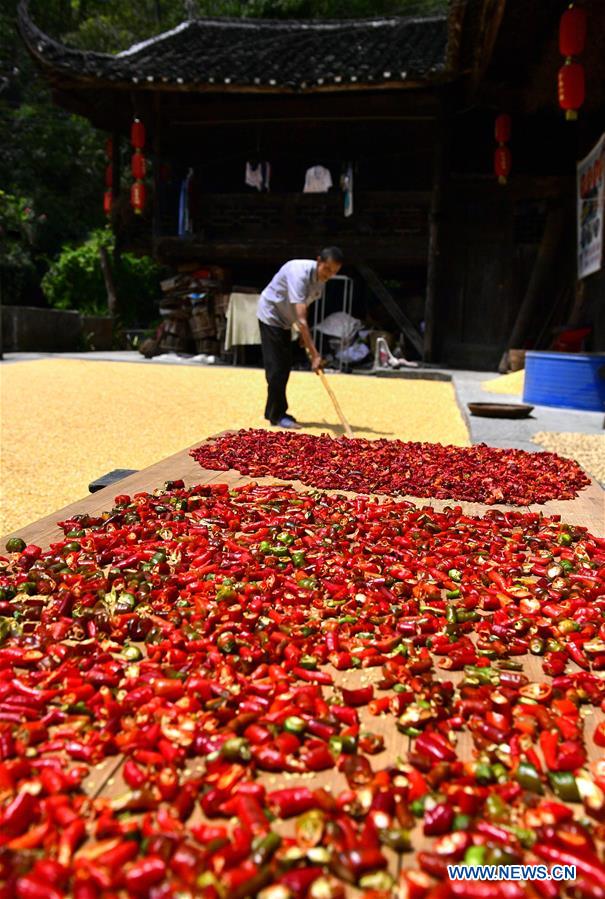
[423,98,448,362]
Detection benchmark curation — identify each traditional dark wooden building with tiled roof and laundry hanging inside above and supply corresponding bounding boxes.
[19,0,605,368]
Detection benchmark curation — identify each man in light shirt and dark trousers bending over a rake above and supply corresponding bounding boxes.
[257,247,343,429]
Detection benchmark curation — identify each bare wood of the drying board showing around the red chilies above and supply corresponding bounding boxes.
[1,438,605,896]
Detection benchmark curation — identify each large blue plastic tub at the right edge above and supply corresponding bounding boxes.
[523,351,605,412]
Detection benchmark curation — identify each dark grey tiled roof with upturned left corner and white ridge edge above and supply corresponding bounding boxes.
[19,0,447,91]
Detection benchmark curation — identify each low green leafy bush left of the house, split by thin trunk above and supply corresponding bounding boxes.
[42,228,160,325]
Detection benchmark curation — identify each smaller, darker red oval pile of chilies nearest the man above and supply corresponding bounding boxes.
[191,429,590,506]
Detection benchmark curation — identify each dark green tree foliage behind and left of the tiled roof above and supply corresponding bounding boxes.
[0,0,447,312]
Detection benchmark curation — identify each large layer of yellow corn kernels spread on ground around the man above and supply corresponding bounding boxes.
[0,359,469,534]
